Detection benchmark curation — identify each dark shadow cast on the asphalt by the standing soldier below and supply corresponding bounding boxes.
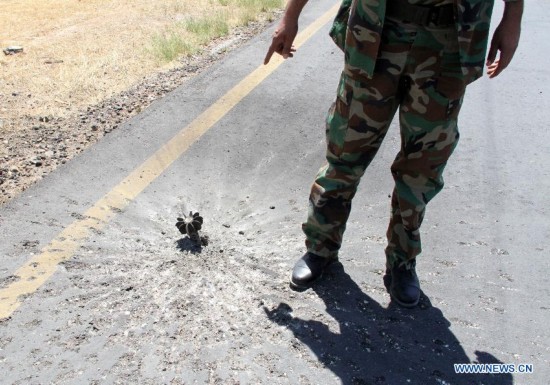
[264,264,513,385]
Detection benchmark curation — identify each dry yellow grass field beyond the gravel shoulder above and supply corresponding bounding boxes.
[0,0,284,133]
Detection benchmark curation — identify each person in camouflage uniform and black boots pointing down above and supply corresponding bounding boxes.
[264,0,523,307]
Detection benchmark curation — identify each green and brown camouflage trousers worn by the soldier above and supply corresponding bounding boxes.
[302,20,466,266]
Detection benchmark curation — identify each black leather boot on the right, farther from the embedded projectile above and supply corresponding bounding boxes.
[384,259,420,308]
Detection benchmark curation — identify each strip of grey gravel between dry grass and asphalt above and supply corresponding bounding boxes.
[0,18,277,205]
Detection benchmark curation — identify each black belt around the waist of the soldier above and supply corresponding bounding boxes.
[386,0,455,26]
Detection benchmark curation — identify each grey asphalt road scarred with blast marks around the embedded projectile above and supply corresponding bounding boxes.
[0,0,550,385]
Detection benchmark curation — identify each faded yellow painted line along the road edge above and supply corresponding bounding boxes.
[0,4,339,319]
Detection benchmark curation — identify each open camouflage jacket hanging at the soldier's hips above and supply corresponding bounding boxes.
[330,0,494,83]
